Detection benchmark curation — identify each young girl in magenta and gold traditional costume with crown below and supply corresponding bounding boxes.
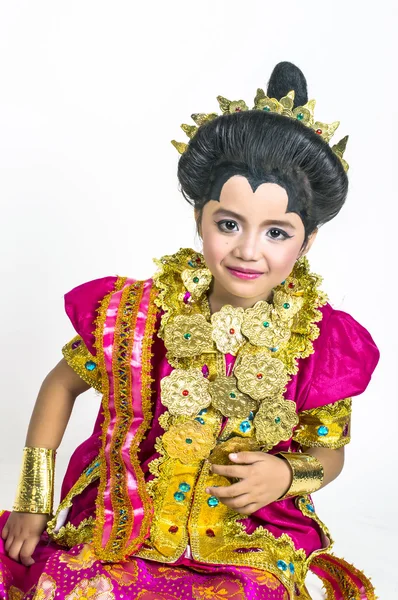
[0,63,378,600]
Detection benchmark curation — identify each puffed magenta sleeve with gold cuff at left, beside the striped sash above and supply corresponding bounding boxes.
[62,276,118,392]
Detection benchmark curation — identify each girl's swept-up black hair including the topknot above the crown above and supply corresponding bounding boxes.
[178,62,348,243]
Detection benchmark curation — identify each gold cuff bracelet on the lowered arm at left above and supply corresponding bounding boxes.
[13,447,55,514]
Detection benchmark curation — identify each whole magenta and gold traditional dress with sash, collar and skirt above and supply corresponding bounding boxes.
[0,249,379,600]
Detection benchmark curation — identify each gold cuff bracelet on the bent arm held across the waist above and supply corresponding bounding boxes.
[276,452,324,500]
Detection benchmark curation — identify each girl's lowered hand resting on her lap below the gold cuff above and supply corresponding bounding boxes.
[1,512,50,567]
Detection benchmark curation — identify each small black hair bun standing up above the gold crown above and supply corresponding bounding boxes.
[267,61,308,107]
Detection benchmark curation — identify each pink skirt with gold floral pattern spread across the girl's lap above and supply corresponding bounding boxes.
[0,513,288,600]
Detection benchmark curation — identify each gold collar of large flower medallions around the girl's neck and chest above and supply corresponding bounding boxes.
[154,248,326,450]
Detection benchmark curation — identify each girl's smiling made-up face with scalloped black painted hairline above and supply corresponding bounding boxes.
[200,175,316,312]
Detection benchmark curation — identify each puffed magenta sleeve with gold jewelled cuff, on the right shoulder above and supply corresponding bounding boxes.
[293,309,379,448]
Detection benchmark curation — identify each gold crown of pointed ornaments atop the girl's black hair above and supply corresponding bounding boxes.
[171,88,348,172]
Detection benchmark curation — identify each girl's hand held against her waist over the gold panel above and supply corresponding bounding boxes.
[206,452,292,515]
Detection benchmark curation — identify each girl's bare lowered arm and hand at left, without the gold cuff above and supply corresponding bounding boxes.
[1,359,90,566]
